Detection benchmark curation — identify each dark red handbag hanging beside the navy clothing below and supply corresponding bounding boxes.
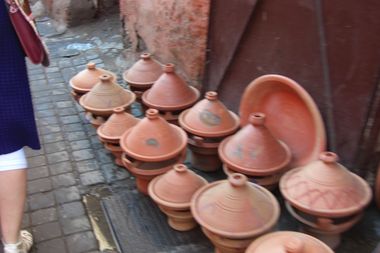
[6,0,50,67]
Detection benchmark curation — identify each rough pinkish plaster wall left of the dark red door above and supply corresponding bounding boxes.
[120,0,210,88]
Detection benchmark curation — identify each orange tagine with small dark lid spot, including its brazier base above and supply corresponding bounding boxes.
[120,109,187,194]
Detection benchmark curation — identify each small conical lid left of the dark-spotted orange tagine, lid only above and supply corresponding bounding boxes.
[97,107,140,140]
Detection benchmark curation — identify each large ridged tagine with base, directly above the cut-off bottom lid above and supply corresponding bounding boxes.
[191,173,280,253]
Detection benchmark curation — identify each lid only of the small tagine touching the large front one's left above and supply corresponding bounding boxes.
[149,164,207,209]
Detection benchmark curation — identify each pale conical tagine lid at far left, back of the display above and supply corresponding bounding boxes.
[69,62,116,93]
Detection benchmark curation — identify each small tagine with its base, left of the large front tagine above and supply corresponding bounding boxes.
[148,164,207,231]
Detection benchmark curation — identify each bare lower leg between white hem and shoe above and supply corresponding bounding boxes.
[0,169,26,243]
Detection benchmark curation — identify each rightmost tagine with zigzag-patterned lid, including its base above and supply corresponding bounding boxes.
[280,152,372,248]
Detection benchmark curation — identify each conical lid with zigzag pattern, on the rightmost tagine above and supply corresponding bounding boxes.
[280,152,372,218]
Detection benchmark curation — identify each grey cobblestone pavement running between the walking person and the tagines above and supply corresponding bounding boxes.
[23,8,138,253]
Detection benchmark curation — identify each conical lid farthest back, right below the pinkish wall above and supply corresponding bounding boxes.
[123,53,162,86]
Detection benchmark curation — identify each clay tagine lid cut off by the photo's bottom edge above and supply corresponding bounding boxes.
[245,231,334,253]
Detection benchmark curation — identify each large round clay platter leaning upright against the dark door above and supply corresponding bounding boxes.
[239,75,326,168]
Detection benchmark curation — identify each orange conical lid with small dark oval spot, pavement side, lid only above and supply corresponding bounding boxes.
[120,109,187,161]
